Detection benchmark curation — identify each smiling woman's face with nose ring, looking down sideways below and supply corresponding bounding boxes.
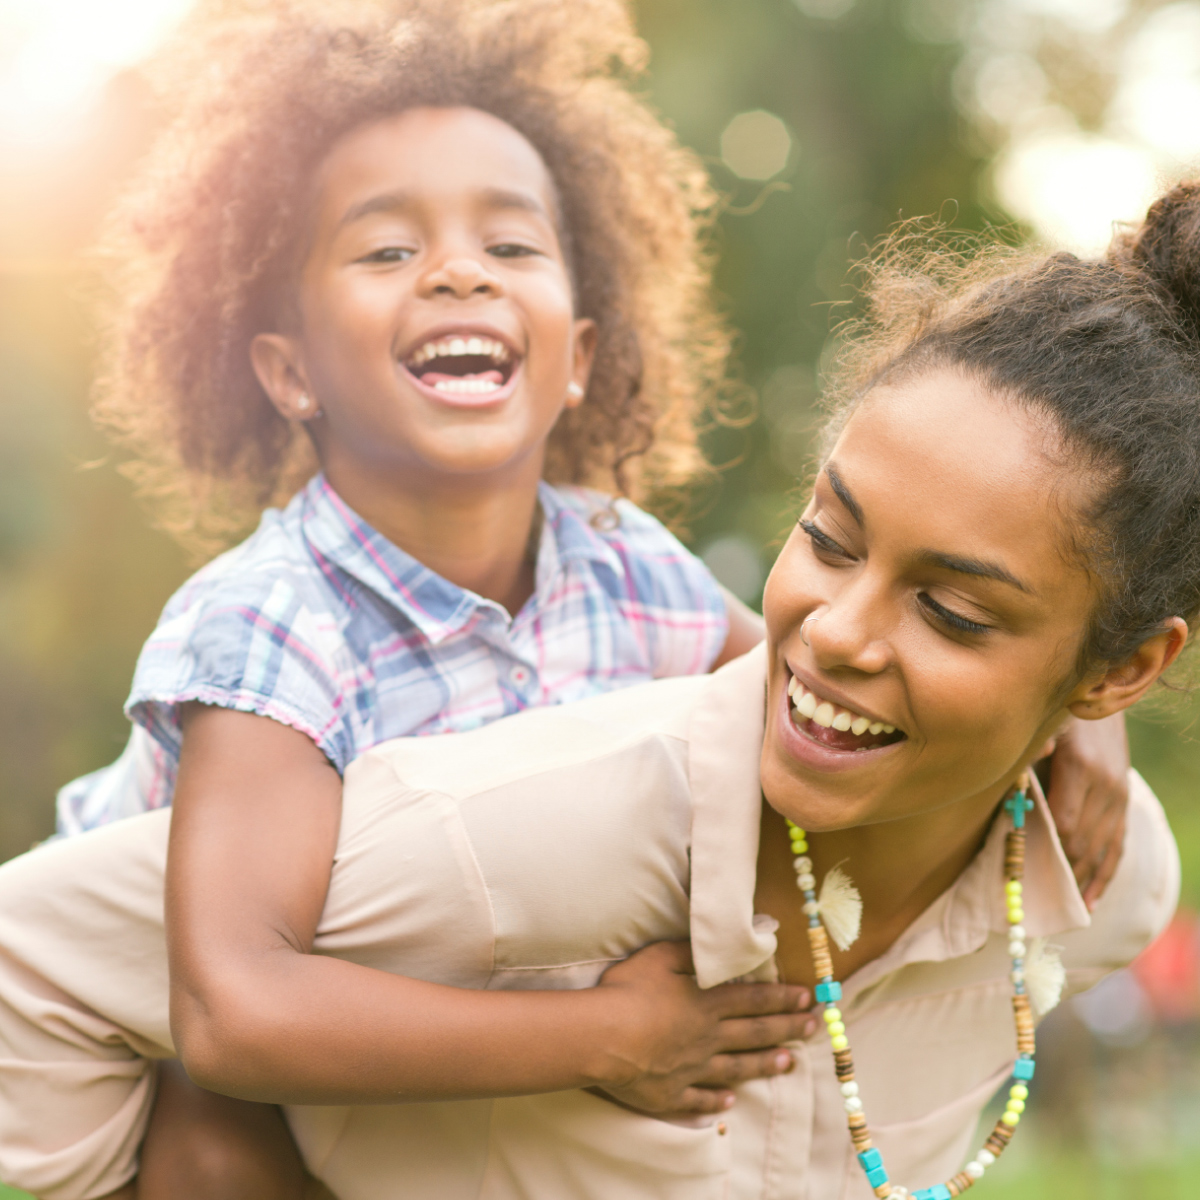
[762,370,1096,830]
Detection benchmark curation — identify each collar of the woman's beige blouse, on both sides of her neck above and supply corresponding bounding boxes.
[688,646,1091,988]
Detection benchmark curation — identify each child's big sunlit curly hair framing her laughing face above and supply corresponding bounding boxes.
[95,0,730,551]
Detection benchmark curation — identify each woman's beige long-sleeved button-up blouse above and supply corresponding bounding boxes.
[0,648,1178,1200]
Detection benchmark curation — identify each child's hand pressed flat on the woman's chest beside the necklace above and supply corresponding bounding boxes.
[590,942,817,1112]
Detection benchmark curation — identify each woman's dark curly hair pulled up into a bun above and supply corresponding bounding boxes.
[826,184,1200,674]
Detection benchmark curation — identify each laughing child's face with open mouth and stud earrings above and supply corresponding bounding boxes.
[253,108,595,487]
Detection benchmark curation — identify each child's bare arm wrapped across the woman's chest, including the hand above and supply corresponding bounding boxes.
[167,704,812,1111]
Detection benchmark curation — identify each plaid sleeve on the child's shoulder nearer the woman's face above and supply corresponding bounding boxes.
[601,500,730,679]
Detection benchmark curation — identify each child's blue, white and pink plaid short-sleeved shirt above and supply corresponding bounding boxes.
[59,475,727,834]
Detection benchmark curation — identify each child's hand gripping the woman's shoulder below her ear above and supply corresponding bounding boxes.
[1046,713,1129,910]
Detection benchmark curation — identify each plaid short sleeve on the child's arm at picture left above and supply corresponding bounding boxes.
[126,572,353,772]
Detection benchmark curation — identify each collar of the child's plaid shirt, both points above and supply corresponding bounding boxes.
[300,473,625,646]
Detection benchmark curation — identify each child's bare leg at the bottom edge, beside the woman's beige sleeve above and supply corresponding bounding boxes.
[137,1061,306,1200]
